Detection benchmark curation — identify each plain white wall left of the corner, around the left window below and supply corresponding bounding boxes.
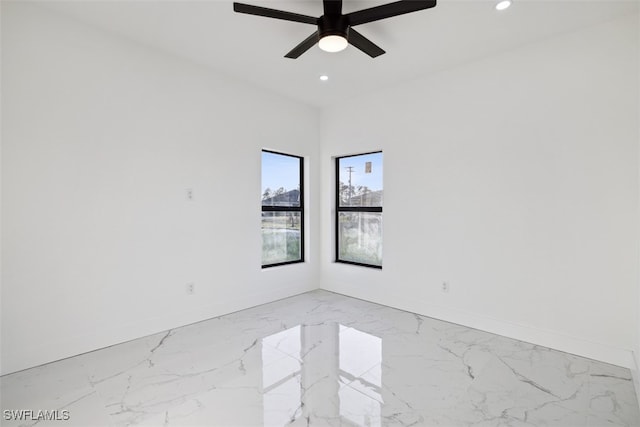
[1,2,319,373]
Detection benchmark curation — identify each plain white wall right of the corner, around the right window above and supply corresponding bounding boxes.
[321,18,639,366]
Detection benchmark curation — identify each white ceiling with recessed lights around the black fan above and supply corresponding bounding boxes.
[36,0,639,106]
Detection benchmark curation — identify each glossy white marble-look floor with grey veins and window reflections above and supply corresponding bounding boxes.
[0,291,640,427]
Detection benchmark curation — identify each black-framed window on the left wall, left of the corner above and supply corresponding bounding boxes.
[262,151,304,268]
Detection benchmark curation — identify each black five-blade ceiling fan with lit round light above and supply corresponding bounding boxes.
[233,0,436,59]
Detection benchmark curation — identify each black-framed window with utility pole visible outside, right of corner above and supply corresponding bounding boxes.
[336,152,383,268]
